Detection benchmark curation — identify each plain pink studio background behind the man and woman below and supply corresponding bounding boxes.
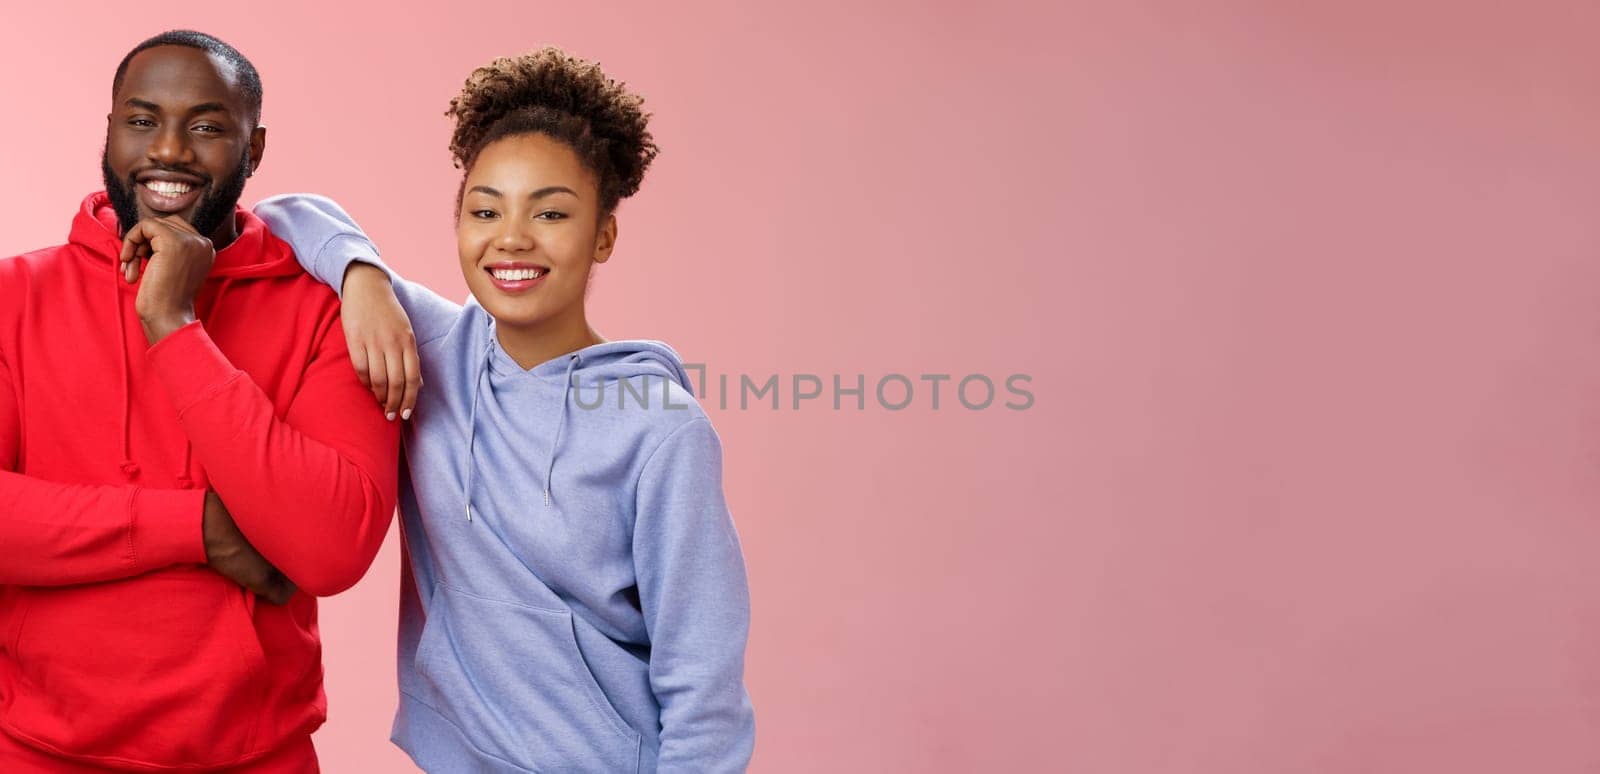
[0,0,1600,774]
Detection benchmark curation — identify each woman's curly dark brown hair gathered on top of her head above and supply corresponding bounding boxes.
[445,46,659,213]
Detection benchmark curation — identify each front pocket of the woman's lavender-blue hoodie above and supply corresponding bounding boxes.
[416,584,640,772]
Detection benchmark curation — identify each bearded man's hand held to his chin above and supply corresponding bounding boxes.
[122,216,216,345]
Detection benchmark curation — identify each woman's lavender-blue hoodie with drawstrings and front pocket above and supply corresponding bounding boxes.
[256,195,755,772]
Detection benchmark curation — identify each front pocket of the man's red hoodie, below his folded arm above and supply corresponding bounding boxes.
[5,568,267,766]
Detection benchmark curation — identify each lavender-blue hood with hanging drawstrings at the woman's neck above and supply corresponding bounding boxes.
[466,335,693,521]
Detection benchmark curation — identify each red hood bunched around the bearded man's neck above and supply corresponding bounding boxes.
[67,190,301,281]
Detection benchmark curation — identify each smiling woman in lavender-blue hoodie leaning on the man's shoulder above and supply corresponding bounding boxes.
[258,48,755,772]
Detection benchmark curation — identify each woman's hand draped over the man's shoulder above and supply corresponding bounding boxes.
[341,264,422,422]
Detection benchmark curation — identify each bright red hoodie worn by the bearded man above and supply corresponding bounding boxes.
[0,194,398,771]
